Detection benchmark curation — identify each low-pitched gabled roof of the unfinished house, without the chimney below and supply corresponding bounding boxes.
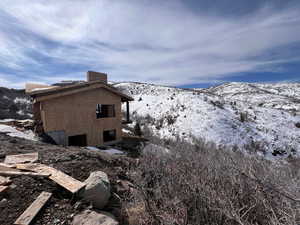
[28,81,134,102]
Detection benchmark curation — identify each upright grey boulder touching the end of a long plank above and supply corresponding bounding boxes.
[83,171,110,209]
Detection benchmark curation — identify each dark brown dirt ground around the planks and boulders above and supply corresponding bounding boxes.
[0,133,136,225]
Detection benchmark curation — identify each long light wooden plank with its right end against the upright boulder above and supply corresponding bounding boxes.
[16,163,85,194]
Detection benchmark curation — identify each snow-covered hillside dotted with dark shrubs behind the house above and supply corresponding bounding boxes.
[115,83,300,155]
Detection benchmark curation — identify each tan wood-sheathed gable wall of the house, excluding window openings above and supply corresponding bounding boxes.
[41,88,122,146]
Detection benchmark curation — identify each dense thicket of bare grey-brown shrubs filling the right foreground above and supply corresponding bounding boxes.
[131,141,300,225]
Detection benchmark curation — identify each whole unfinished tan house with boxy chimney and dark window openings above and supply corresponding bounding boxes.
[26,71,133,146]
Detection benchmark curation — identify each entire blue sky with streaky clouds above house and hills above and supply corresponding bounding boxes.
[0,0,300,88]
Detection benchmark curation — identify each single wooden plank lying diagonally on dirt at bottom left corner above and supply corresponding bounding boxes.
[14,191,52,225]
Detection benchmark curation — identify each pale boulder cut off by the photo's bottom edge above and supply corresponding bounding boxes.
[72,210,119,225]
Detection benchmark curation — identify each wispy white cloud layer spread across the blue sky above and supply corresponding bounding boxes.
[0,0,300,88]
